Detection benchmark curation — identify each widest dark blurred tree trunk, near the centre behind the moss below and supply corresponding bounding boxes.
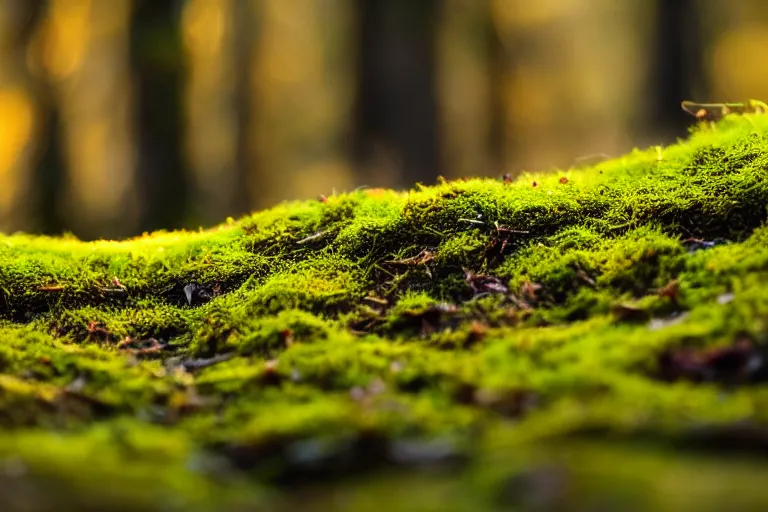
[353,0,442,186]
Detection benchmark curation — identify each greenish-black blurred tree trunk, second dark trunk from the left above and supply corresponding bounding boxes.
[131,0,189,231]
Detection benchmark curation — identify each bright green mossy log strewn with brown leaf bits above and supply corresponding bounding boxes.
[0,115,768,511]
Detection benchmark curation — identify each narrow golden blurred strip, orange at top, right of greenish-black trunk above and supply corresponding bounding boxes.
[182,0,254,224]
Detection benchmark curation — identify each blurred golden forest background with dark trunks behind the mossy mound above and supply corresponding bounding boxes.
[0,0,768,238]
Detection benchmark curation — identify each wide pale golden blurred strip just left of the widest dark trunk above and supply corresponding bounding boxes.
[249,0,354,207]
